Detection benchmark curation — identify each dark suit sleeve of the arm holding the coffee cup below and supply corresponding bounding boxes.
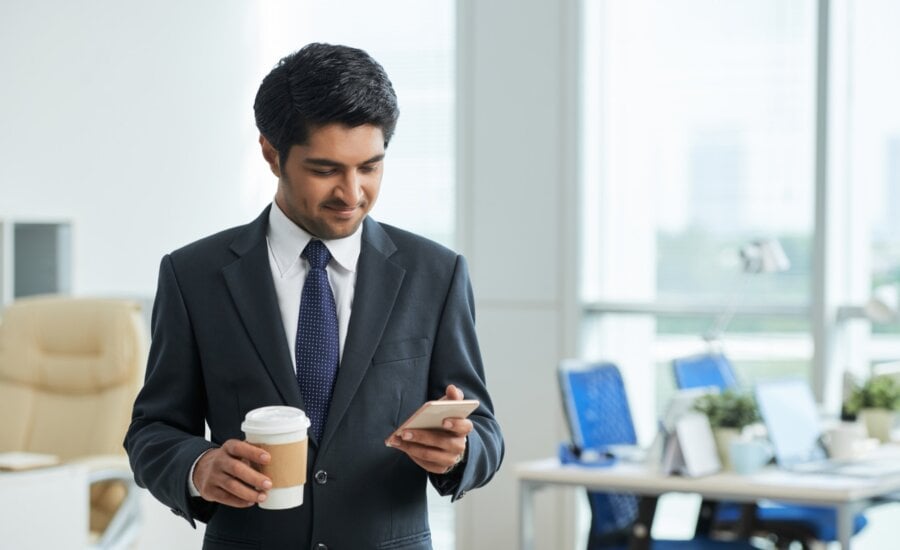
[125,256,215,525]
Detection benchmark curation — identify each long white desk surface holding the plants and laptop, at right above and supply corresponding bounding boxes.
[516,458,900,505]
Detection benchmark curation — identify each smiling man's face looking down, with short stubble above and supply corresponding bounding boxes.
[259,124,384,239]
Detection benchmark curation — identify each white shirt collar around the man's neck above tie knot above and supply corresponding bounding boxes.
[266,201,362,275]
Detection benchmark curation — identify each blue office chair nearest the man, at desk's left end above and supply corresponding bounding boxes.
[559,361,755,550]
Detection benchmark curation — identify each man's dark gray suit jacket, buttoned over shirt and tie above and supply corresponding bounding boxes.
[125,209,503,550]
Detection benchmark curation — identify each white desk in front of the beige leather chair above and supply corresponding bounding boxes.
[0,466,90,550]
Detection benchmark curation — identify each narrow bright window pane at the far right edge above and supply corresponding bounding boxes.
[835,0,900,367]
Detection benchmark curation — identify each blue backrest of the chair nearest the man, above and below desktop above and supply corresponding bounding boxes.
[559,360,637,546]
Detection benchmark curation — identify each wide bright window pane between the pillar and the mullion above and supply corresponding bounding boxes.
[581,0,815,434]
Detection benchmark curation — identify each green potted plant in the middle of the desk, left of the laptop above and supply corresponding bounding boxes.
[694,390,759,470]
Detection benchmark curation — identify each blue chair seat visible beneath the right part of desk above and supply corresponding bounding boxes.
[716,502,868,542]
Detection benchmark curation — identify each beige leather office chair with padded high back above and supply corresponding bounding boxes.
[0,296,147,549]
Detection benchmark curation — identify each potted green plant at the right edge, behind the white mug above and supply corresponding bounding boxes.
[844,376,900,442]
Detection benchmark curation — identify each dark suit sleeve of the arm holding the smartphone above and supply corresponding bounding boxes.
[429,256,504,501]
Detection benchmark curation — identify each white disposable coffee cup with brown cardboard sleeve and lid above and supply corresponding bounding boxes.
[241,406,309,510]
